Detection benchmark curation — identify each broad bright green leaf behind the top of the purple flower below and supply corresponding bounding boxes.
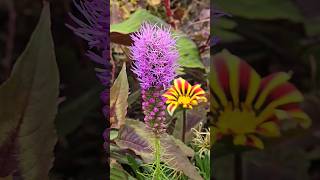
[110,9,204,69]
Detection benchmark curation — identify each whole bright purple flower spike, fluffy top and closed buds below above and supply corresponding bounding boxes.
[130,23,179,134]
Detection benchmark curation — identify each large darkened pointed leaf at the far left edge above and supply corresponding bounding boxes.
[0,3,59,180]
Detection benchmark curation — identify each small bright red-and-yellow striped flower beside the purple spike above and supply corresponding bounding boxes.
[162,78,207,116]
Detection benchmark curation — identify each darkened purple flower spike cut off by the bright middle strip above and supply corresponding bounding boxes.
[67,0,111,118]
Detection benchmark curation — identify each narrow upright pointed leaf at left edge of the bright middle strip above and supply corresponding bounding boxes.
[110,63,129,129]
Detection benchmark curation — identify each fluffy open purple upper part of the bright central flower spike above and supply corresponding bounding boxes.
[131,23,179,90]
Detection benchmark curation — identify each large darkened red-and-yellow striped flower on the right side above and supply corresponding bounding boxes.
[209,51,311,149]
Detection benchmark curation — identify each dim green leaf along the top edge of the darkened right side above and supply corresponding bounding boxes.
[215,0,303,22]
